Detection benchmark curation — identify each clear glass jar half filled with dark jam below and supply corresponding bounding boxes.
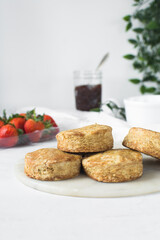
[74,71,102,111]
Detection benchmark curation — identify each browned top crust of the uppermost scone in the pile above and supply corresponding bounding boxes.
[57,124,112,138]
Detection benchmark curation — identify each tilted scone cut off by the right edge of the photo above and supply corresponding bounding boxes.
[123,127,160,158]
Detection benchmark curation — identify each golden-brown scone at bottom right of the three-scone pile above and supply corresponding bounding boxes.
[82,149,143,182]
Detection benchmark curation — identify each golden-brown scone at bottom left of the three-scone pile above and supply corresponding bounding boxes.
[24,148,82,181]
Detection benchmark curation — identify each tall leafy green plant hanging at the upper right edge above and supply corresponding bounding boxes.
[123,0,160,94]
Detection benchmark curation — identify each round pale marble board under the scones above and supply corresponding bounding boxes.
[15,158,160,198]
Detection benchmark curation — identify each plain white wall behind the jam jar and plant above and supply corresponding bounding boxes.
[0,0,139,110]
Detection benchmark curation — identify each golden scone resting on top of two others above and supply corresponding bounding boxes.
[56,124,113,153]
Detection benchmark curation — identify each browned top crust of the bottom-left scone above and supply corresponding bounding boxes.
[25,148,82,164]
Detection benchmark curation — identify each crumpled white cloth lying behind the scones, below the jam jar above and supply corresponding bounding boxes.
[17,106,130,146]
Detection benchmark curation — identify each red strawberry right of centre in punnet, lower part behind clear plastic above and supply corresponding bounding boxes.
[24,119,44,142]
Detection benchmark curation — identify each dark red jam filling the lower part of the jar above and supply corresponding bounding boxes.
[75,84,102,111]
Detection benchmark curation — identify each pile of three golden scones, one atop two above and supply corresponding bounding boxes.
[25,124,148,182]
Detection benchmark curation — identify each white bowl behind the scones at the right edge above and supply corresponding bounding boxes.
[124,95,160,127]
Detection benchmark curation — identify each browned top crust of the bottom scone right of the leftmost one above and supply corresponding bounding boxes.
[83,149,142,165]
